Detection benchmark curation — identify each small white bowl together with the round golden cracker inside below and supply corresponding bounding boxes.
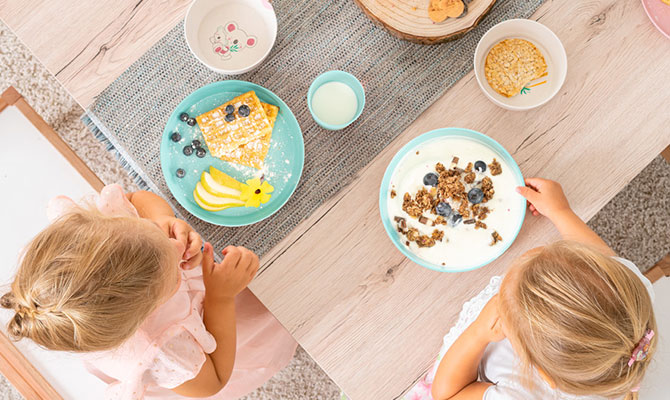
[474,19,568,111]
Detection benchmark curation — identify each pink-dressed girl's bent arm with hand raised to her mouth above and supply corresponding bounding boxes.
[126,190,202,269]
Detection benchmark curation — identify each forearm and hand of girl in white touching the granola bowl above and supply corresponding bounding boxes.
[517,178,616,256]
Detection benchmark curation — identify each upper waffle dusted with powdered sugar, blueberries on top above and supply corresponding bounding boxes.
[195,90,272,157]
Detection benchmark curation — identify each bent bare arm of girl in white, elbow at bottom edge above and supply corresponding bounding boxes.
[432,295,505,400]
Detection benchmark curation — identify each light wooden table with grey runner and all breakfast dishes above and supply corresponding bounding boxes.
[0,0,670,400]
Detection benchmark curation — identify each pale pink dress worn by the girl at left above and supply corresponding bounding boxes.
[48,185,297,400]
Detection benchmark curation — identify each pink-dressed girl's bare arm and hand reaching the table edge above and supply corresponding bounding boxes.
[173,243,258,397]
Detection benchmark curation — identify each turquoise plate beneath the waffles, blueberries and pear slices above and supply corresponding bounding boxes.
[160,79,305,227]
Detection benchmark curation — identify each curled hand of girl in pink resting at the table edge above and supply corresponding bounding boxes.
[202,243,259,300]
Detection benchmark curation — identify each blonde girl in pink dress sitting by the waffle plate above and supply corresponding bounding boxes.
[1,185,296,400]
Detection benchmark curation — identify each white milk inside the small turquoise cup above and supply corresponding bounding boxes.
[312,82,358,125]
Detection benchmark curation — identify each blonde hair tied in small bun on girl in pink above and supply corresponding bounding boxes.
[0,208,173,351]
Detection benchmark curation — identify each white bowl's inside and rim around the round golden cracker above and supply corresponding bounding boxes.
[474,19,568,111]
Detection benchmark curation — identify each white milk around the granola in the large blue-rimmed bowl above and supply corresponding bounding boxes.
[388,138,526,270]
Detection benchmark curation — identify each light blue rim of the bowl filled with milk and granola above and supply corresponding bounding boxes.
[379,128,526,272]
